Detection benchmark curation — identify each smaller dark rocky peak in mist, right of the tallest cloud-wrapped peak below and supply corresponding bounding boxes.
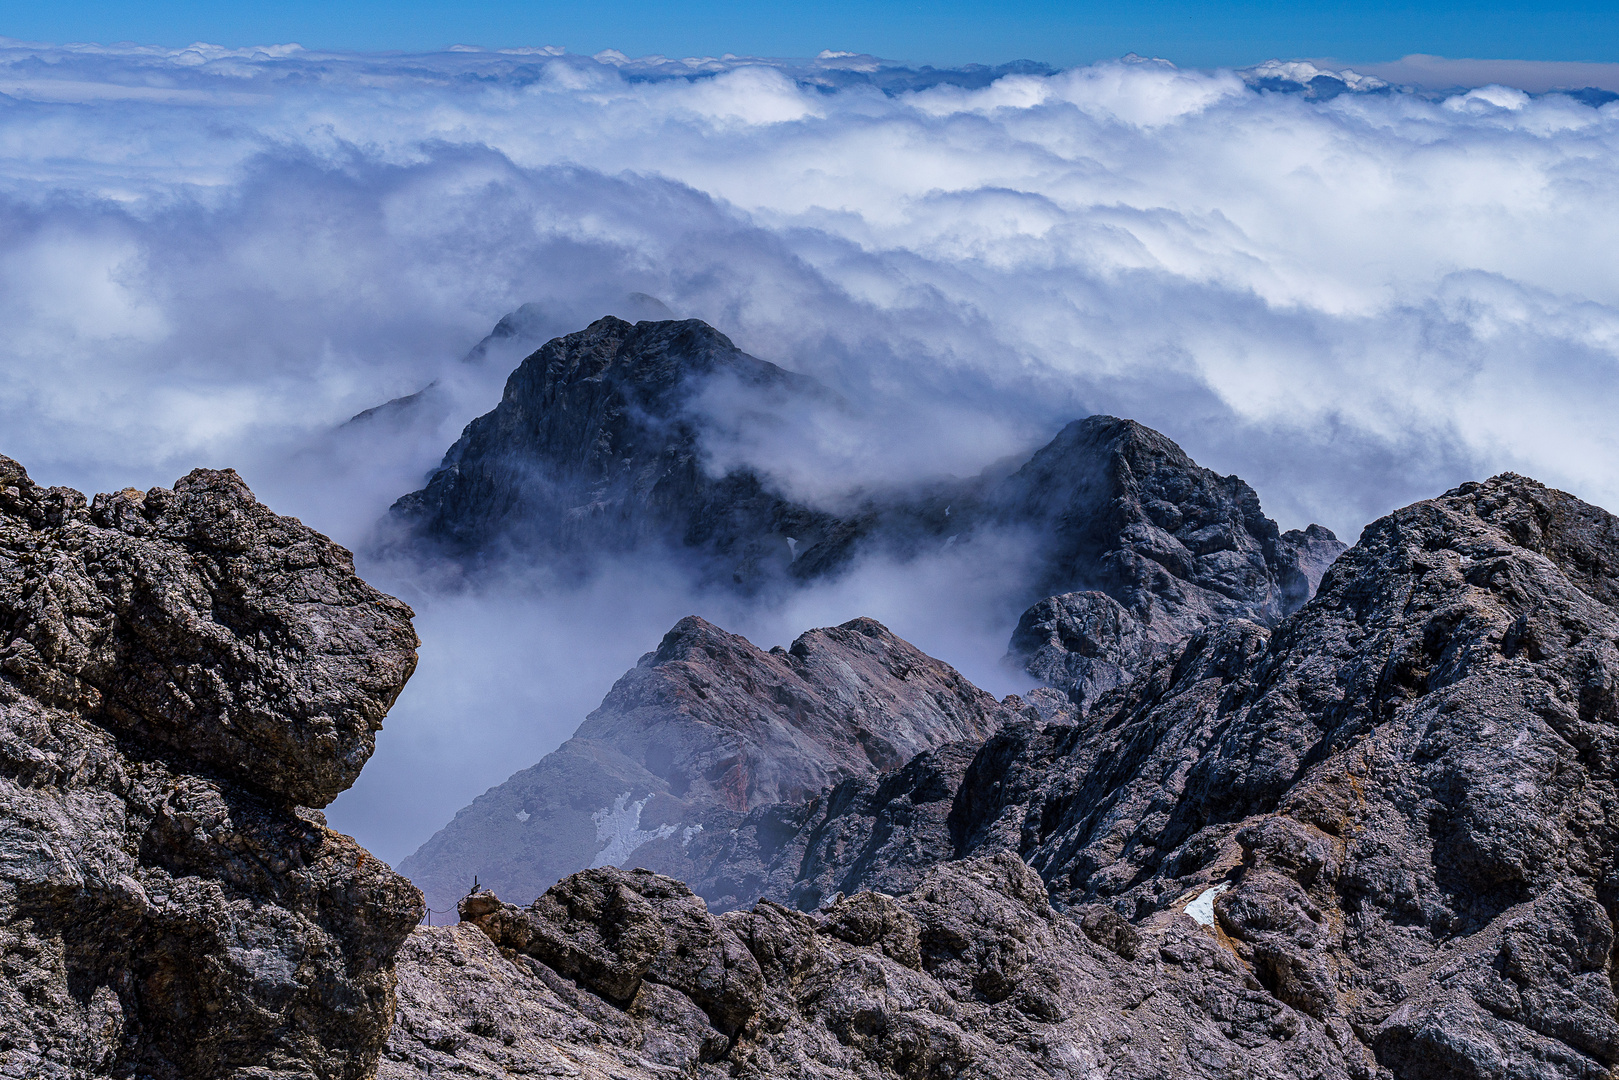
[988,416,1344,709]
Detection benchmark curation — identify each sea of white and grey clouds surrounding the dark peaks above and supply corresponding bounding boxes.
[0,40,1619,860]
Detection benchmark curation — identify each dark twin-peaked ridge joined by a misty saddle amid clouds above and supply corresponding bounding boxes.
[393,317,1344,709]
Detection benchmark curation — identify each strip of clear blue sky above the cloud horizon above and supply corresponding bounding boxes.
[0,0,1619,66]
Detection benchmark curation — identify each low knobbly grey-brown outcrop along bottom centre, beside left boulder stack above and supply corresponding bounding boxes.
[377,853,1371,1080]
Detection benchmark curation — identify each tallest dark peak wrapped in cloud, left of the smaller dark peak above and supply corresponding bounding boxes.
[393,316,840,588]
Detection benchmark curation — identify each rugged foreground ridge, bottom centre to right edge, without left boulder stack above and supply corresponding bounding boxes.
[379,474,1619,1080]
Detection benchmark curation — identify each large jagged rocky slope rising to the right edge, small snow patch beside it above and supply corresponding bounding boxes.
[952,474,1619,1078]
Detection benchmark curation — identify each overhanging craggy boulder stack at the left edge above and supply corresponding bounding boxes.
[0,458,421,1080]
